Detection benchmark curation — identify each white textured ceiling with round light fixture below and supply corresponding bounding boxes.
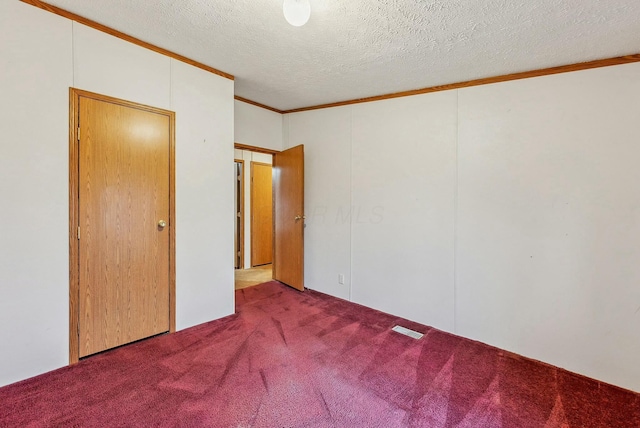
[47,0,640,110]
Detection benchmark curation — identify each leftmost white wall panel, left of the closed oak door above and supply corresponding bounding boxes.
[0,1,73,386]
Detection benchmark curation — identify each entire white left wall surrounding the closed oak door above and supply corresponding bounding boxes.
[0,1,234,385]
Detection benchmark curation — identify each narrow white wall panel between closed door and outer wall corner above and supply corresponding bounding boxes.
[171,60,235,329]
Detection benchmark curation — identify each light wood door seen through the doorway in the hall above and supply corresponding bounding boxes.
[251,162,273,267]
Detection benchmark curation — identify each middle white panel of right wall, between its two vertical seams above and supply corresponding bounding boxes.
[351,92,457,331]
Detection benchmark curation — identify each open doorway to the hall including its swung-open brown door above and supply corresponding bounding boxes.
[234,143,306,291]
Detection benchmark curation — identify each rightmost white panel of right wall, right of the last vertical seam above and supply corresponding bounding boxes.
[456,60,640,390]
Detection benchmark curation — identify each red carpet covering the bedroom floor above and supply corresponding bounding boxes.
[0,282,640,428]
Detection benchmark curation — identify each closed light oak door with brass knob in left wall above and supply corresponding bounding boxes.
[78,97,172,357]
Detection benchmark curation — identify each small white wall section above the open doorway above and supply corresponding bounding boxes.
[234,100,282,150]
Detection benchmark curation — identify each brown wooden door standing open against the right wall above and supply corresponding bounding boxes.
[273,145,304,291]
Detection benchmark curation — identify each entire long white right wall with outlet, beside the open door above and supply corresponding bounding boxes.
[283,64,640,391]
